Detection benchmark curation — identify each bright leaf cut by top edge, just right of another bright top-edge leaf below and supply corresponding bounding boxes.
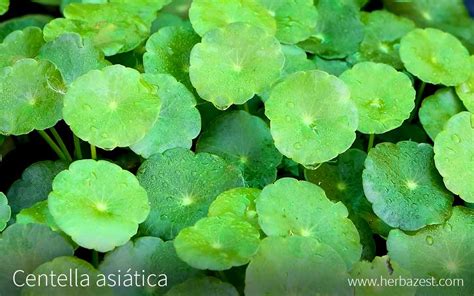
[258,0,318,44]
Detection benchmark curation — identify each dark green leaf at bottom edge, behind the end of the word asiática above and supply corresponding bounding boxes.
[100,237,198,296]
